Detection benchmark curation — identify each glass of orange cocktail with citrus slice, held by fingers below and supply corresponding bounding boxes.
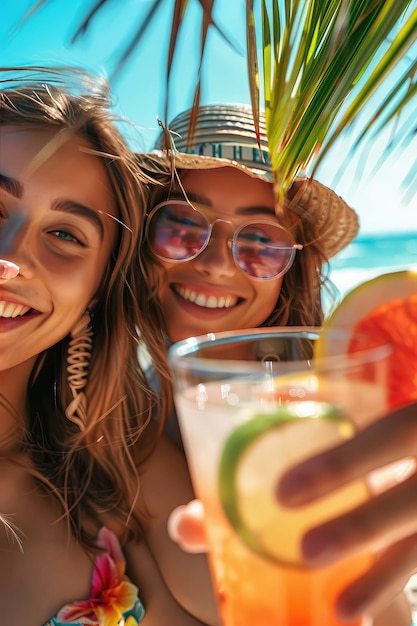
[169,328,390,626]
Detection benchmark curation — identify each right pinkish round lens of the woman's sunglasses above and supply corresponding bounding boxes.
[233,223,295,278]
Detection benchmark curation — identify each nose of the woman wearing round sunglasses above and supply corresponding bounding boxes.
[193,220,237,278]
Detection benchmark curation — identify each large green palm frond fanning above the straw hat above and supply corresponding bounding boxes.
[262,0,417,194]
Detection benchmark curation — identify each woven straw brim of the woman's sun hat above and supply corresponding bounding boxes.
[138,150,359,259]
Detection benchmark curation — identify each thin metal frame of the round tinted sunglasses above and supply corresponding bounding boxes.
[145,199,304,280]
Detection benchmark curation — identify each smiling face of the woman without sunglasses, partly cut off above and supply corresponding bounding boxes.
[0,126,116,370]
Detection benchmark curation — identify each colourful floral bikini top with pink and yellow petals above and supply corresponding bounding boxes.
[44,528,145,626]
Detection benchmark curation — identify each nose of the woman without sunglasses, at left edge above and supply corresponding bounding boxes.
[0,213,31,280]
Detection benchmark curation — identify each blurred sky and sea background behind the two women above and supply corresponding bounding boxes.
[0,0,417,296]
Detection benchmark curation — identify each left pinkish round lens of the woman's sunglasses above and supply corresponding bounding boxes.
[148,201,210,261]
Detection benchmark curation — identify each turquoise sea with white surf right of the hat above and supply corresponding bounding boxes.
[324,232,417,304]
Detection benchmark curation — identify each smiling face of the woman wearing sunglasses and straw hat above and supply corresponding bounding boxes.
[151,167,282,341]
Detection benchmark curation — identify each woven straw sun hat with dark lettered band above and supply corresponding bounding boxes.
[142,104,359,258]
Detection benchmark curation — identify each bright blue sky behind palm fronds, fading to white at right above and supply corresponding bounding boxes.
[0,0,417,233]
